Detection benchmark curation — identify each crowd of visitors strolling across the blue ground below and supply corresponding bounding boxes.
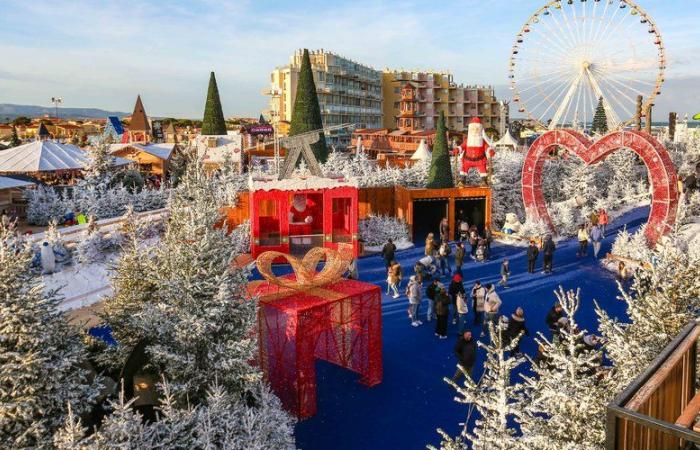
[381,210,608,381]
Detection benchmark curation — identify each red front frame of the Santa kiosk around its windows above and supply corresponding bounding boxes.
[250,186,359,258]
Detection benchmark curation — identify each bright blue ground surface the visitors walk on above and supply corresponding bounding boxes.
[274,208,649,450]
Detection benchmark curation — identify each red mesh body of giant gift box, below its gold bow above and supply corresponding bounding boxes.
[249,280,382,419]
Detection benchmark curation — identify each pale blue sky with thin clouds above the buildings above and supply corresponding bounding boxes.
[0,0,700,118]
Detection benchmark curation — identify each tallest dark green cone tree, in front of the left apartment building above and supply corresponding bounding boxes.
[289,49,328,162]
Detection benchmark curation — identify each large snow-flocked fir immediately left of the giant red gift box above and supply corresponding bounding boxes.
[105,162,260,400]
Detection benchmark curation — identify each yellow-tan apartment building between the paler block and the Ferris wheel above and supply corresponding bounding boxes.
[382,70,508,134]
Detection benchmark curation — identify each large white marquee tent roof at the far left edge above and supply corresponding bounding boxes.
[0,141,131,173]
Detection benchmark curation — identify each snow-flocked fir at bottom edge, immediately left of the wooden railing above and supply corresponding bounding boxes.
[518,287,614,450]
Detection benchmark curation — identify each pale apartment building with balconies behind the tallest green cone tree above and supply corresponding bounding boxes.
[265,49,382,148]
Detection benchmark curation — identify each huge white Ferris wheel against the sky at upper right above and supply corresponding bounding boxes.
[508,0,666,130]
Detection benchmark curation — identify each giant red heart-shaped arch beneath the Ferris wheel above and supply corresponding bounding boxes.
[522,130,678,246]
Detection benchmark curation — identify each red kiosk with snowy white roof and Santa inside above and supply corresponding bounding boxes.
[250,175,359,258]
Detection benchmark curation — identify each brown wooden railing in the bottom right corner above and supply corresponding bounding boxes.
[606,322,700,450]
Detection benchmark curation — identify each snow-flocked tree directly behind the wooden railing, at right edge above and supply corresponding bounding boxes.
[596,234,700,392]
